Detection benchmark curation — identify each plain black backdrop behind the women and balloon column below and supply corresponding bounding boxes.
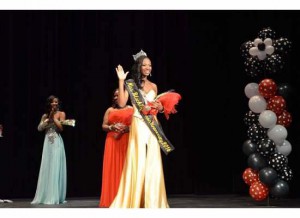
[0,10,300,198]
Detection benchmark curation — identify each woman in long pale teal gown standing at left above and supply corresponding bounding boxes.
[31,95,67,204]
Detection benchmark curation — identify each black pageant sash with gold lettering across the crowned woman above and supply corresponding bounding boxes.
[125,79,175,155]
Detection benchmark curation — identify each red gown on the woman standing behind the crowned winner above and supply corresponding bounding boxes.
[99,107,133,207]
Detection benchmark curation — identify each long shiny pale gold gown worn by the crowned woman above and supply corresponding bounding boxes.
[110,90,169,208]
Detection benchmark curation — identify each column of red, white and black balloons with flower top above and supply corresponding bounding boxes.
[241,28,293,201]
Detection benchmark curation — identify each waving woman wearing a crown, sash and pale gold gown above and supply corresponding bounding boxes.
[110,50,180,208]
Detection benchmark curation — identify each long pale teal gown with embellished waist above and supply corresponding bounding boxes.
[31,124,67,204]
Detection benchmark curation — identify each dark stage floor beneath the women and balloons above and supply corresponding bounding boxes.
[0,195,300,209]
